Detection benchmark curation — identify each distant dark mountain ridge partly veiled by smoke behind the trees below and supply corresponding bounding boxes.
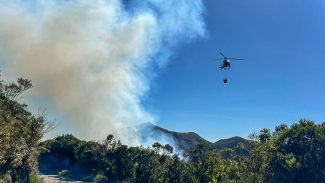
[136,123,252,154]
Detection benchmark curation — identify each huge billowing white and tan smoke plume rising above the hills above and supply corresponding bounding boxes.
[0,0,205,145]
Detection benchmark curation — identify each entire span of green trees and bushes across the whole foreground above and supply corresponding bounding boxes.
[0,75,325,183]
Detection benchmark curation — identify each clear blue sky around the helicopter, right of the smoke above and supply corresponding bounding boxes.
[145,0,325,141]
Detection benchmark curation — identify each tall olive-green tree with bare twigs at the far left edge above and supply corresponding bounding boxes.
[0,74,51,182]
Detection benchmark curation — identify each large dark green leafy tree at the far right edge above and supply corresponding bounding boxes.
[276,119,325,182]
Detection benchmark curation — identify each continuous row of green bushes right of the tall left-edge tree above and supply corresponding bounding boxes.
[40,120,325,182]
